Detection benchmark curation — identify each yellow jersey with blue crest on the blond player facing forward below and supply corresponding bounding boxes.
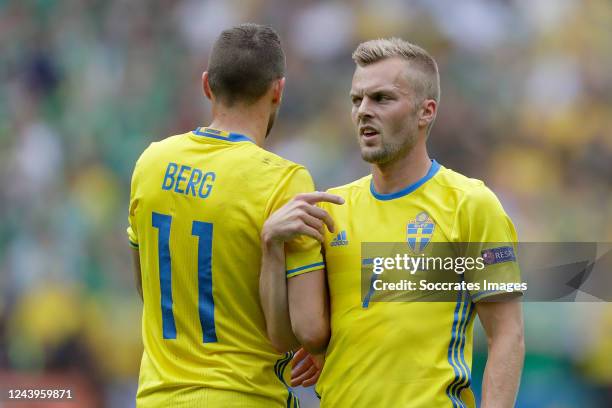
[310,161,520,408]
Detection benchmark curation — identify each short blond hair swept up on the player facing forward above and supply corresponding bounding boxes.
[353,37,440,102]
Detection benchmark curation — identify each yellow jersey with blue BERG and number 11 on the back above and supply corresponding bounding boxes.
[128,128,323,408]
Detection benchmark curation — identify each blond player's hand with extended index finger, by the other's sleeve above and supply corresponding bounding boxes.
[261,191,344,242]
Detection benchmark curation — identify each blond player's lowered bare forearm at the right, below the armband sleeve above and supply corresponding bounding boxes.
[481,328,525,408]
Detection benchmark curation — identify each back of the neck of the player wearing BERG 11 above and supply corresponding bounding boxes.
[209,103,270,146]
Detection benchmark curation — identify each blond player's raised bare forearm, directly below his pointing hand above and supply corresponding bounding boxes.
[259,238,299,352]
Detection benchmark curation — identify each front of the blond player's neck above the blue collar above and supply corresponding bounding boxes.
[372,143,431,194]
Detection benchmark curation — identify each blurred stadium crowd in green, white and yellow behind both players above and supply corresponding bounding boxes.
[0,0,612,408]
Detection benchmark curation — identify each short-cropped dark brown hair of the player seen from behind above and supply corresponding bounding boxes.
[208,23,285,106]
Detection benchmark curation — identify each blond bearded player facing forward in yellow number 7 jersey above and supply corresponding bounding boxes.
[262,38,524,408]
